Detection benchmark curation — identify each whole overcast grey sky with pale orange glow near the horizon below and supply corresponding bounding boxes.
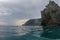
[0,0,60,25]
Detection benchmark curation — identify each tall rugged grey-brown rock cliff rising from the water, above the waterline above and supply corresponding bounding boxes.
[41,1,60,26]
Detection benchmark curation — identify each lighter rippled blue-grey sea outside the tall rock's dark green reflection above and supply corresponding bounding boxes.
[0,26,60,40]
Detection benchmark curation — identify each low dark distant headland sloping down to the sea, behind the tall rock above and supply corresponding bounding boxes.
[23,19,41,26]
